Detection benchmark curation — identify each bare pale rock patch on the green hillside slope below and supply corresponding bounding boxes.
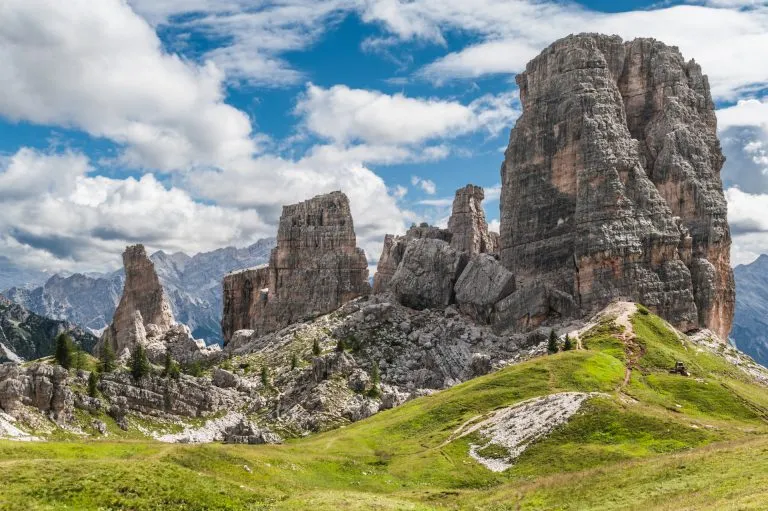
[456,392,596,472]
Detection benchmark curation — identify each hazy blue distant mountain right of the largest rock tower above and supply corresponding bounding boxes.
[731,254,768,367]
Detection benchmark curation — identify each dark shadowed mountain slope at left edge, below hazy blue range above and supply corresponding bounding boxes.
[0,295,97,362]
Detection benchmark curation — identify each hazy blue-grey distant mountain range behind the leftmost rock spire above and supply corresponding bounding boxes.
[0,238,275,344]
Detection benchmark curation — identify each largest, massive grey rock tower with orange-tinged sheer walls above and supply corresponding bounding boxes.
[501,34,734,338]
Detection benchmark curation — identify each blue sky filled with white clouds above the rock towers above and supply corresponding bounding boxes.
[0,0,768,271]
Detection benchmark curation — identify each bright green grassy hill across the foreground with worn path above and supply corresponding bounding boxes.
[0,308,768,511]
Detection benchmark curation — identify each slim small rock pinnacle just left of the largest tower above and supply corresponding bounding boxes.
[448,185,498,254]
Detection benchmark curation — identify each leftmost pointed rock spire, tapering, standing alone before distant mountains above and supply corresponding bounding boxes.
[99,245,175,355]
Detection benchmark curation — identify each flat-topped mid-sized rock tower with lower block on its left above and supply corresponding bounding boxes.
[222,192,370,341]
